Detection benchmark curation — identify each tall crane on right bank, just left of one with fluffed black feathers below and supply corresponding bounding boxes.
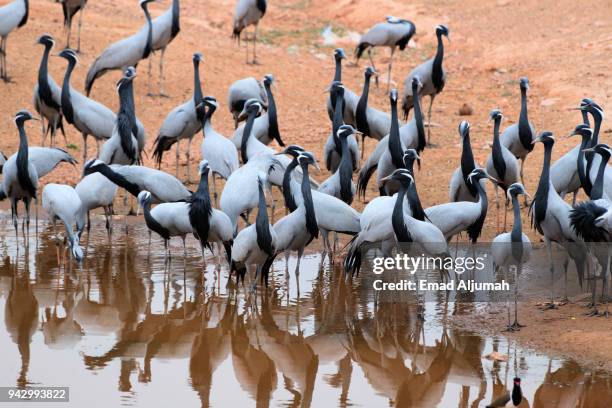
[529,131,586,309]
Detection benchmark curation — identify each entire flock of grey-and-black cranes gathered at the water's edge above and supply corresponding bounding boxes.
[0,0,612,336]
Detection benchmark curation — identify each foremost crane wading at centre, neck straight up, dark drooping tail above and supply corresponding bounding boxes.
[231,172,277,289]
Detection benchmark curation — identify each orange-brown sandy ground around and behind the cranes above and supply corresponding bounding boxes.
[0,0,612,368]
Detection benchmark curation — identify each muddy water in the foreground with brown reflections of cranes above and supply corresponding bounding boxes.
[0,214,612,407]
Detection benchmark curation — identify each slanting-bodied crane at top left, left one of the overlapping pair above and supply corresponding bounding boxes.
[85,0,155,96]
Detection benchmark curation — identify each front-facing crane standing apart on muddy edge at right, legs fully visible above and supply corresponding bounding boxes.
[491,183,531,331]
